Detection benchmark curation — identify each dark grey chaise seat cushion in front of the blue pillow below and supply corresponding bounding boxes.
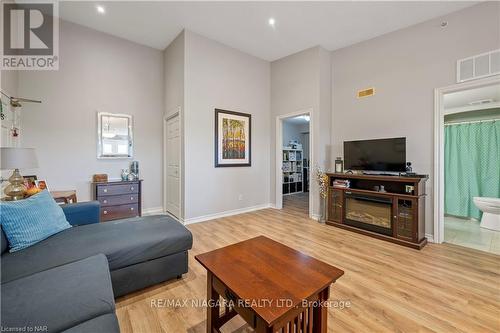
[1,215,193,282]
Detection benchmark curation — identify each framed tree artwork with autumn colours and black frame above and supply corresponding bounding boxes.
[215,109,252,168]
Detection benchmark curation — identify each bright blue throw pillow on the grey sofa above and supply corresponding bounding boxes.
[0,190,71,252]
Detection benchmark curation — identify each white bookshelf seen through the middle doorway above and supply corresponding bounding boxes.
[281,147,304,195]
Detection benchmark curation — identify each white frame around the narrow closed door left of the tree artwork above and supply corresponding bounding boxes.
[162,106,184,222]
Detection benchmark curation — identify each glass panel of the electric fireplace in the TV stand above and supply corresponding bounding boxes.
[345,197,391,229]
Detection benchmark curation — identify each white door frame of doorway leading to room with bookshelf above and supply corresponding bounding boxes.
[275,108,316,218]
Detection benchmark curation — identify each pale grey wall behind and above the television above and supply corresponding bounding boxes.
[332,2,500,234]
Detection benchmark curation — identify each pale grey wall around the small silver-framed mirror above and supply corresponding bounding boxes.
[15,22,164,209]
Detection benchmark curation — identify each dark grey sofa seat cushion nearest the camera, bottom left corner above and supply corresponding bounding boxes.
[1,254,115,332]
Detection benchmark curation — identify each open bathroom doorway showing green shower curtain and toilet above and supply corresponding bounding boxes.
[436,83,500,254]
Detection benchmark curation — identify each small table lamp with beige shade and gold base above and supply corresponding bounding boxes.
[0,147,38,200]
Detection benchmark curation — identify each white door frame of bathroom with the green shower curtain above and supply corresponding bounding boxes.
[433,75,500,243]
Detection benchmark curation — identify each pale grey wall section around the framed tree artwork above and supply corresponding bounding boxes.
[184,31,270,222]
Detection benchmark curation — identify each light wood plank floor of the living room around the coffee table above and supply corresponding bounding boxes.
[117,200,500,333]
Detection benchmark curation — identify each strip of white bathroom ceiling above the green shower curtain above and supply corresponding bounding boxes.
[443,84,500,109]
